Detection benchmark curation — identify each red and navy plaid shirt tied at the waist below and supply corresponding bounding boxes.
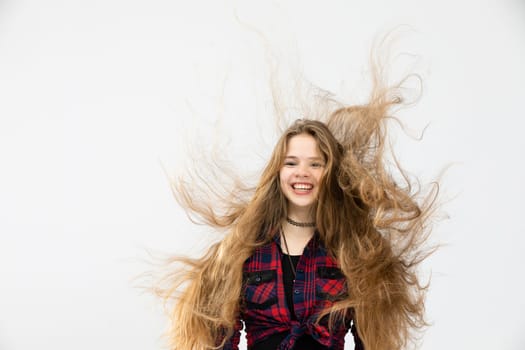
[224,235,364,350]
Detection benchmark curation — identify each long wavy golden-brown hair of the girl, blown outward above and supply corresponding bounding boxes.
[158,65,436,350]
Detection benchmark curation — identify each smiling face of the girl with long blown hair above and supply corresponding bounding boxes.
[279,134,325,215]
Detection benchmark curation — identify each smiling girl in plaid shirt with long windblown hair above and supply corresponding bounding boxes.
[162,69,435,350]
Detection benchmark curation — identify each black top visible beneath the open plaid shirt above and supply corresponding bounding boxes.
[249,253,328,350]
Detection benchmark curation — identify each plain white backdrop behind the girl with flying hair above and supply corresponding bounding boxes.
[0,0,525,350]
